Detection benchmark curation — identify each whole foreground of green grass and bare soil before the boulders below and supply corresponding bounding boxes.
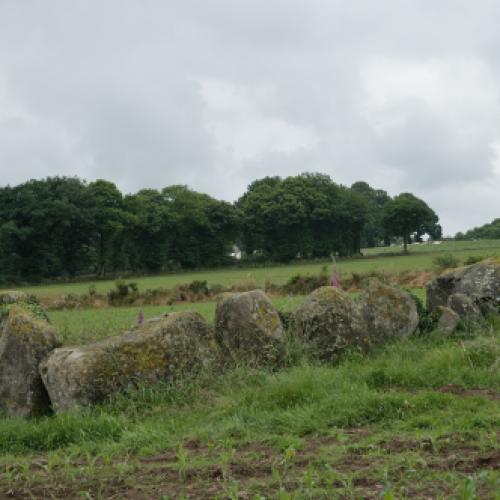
[0,320,500,499]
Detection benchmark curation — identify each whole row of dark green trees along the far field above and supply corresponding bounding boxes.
[0,173,440,283]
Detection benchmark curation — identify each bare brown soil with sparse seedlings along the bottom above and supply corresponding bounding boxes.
[0,426,500,500]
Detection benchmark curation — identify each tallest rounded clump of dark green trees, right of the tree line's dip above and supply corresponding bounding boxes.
[236,174,368,261]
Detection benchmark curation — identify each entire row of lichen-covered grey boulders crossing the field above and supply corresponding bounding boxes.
[0,261,500,417]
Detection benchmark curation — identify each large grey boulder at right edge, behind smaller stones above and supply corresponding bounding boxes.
[427,260,500,314]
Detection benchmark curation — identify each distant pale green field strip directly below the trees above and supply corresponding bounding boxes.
[6,240,500,297]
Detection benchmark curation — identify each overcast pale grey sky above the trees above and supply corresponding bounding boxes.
[0,0,500,234]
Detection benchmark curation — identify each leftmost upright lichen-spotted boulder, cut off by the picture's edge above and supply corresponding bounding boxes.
[0,304,61,417]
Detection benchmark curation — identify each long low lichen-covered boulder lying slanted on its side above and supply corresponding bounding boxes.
[40,312,213,412]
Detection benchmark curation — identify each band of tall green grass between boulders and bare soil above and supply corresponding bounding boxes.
[0,320,500,455]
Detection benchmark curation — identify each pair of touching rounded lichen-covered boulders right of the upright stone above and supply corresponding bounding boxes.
[290,282,418,360]
